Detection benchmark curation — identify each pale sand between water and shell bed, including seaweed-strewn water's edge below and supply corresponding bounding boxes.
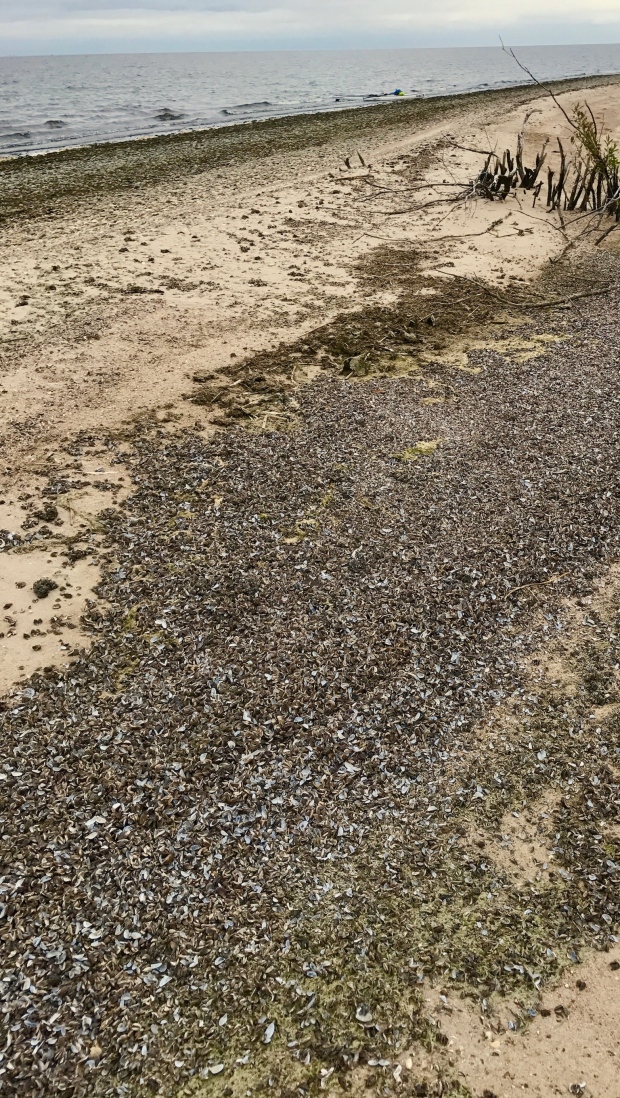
[0,78,620,475]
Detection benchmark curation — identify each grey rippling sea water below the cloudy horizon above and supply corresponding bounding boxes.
[0,45,620,156]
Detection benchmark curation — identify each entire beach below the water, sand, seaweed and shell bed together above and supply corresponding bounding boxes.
[0,78,620,1098]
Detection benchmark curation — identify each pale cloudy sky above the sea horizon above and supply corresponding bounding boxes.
[0,0,620,56]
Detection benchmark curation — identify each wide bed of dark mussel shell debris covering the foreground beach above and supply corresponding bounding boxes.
[0,260,620,1098]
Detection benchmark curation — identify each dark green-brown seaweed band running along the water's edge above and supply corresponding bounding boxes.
[0,74,620,225]
